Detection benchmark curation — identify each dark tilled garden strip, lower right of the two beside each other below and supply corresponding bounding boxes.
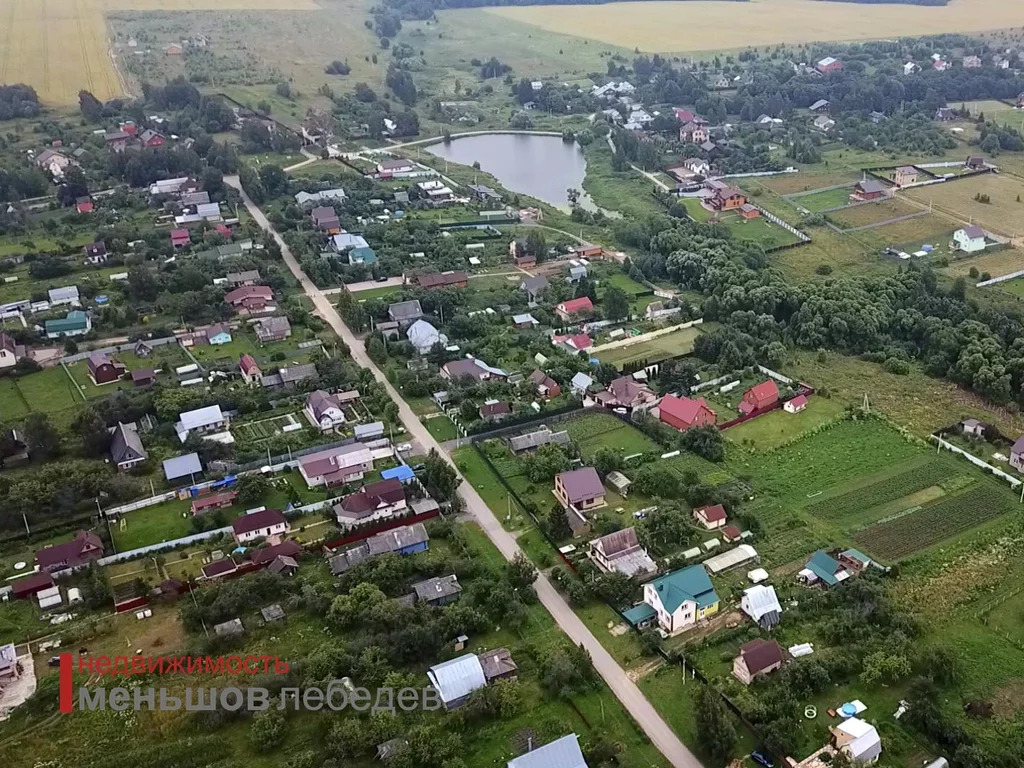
[853,487,1013,560]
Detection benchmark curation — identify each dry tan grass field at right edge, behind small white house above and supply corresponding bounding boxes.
[904,173,1024,237]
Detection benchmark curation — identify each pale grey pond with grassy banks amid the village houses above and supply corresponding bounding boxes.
[424,133,607,213]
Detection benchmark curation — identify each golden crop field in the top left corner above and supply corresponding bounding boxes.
[0,0,317,104]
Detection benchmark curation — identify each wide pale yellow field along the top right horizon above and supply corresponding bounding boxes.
[487,0,1024,53]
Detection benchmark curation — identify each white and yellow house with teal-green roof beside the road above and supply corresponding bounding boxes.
[623,564,721,635]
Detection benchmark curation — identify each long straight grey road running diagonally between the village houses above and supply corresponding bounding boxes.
[224,176,702,768]
